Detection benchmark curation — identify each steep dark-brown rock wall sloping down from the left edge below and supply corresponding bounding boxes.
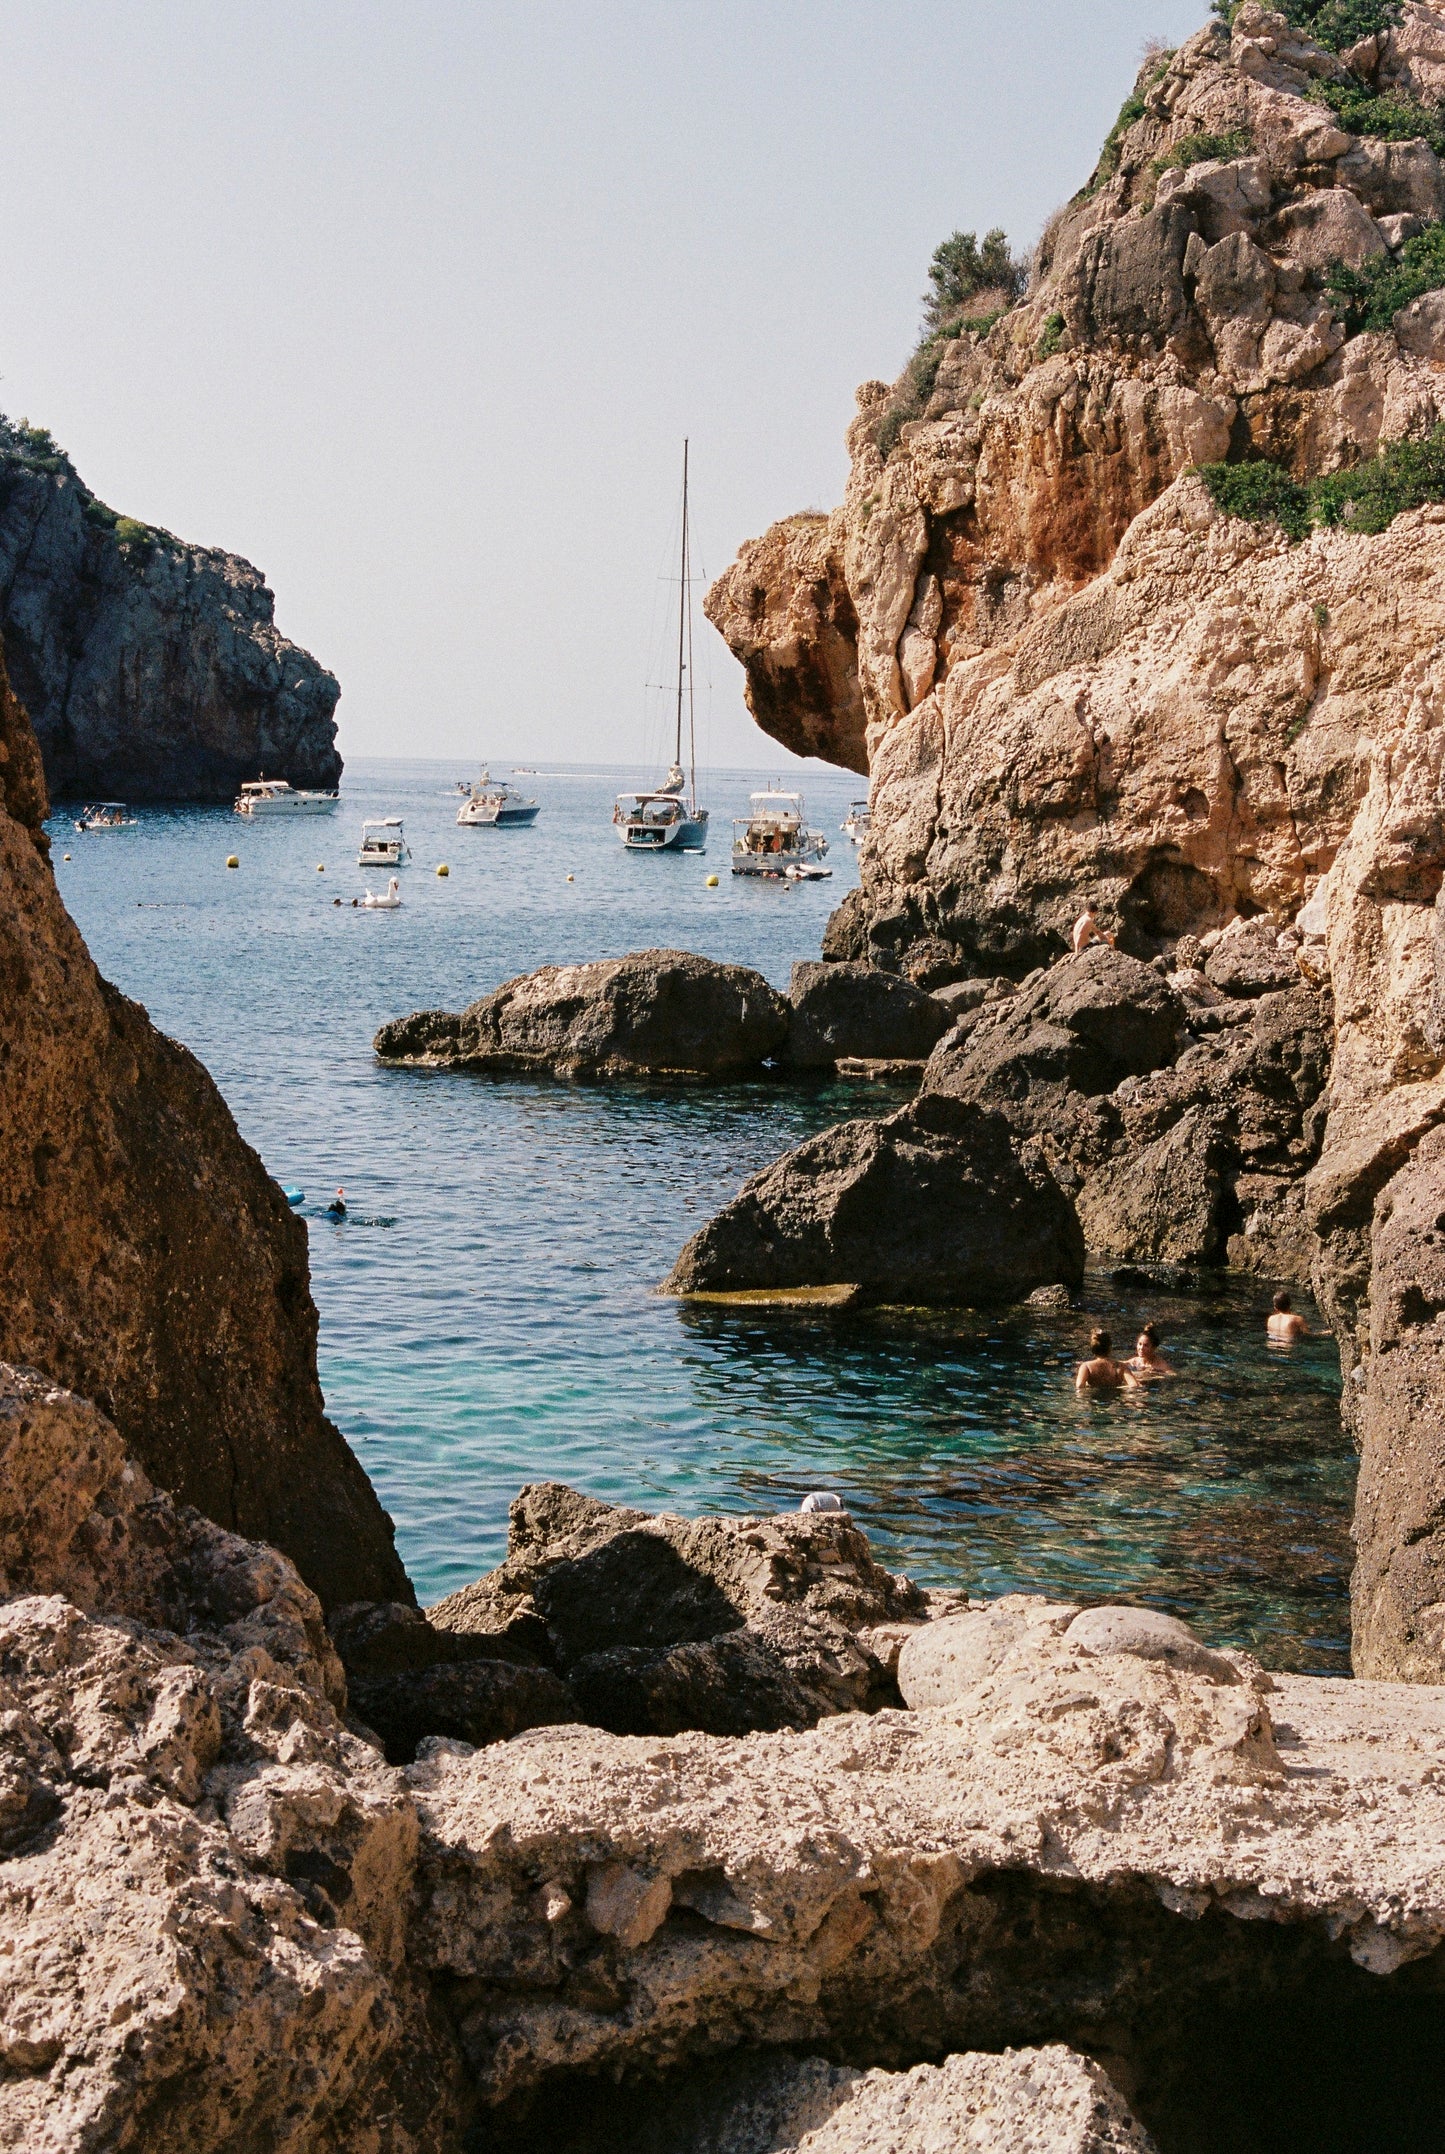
[0,646,411,1600]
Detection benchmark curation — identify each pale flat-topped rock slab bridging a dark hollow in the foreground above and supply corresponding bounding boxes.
[407,1609,1445,2145]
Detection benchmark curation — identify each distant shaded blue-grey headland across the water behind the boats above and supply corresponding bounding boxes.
[0,420,340,801]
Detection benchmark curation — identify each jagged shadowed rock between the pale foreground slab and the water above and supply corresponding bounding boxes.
[430,1482,926,1736]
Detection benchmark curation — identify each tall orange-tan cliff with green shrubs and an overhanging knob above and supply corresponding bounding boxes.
[709,0,1445,1682]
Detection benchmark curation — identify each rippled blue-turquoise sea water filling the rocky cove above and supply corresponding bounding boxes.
[52,763,1355,1672]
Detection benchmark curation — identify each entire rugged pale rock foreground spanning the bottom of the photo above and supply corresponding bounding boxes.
[0,1370,1445,2154]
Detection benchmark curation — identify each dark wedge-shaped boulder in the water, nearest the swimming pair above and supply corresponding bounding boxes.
[665,1094,1083,1305]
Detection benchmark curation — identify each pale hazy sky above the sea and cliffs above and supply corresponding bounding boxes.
[0,0,1208,763]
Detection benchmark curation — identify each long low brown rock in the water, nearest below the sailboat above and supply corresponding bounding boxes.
[375,950,788,1079]
